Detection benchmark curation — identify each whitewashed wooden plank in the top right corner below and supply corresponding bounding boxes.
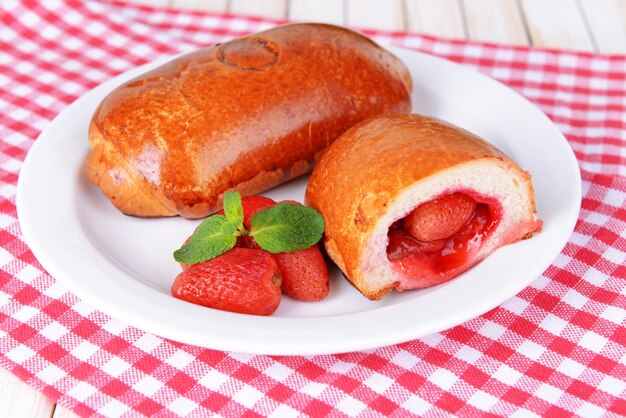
[580,0,626,54]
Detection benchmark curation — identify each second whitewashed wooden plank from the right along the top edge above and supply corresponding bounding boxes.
[520,0,594,51]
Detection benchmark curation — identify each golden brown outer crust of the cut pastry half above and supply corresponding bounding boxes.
[306,114,534,300]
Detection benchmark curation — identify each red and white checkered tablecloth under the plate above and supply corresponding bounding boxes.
[0,0,626,417]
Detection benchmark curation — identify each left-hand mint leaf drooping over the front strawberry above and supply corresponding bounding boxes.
[174,215,237,264]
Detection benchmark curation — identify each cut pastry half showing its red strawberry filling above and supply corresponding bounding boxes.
[306,114,542,300]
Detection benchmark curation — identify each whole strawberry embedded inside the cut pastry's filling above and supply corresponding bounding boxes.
[403,193,476,242]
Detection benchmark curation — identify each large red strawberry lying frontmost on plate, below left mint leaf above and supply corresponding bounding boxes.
[172,248,281,315]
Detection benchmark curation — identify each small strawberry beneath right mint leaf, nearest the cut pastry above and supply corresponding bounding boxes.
[274,244,330,302]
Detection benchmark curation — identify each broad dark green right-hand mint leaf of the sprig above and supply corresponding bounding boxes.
[250,203,324,253]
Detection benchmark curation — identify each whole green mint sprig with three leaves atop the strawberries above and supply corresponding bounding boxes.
[174,192,324,264]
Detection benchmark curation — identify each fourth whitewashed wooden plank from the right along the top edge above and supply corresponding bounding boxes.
[406,0,467,39]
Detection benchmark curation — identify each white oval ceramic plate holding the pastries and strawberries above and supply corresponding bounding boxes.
[17,48,581,354]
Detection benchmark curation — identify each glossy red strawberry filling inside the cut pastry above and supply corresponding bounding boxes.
[387,192,501,289]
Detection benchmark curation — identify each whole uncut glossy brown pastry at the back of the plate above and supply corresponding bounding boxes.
[87,24,411,218]
